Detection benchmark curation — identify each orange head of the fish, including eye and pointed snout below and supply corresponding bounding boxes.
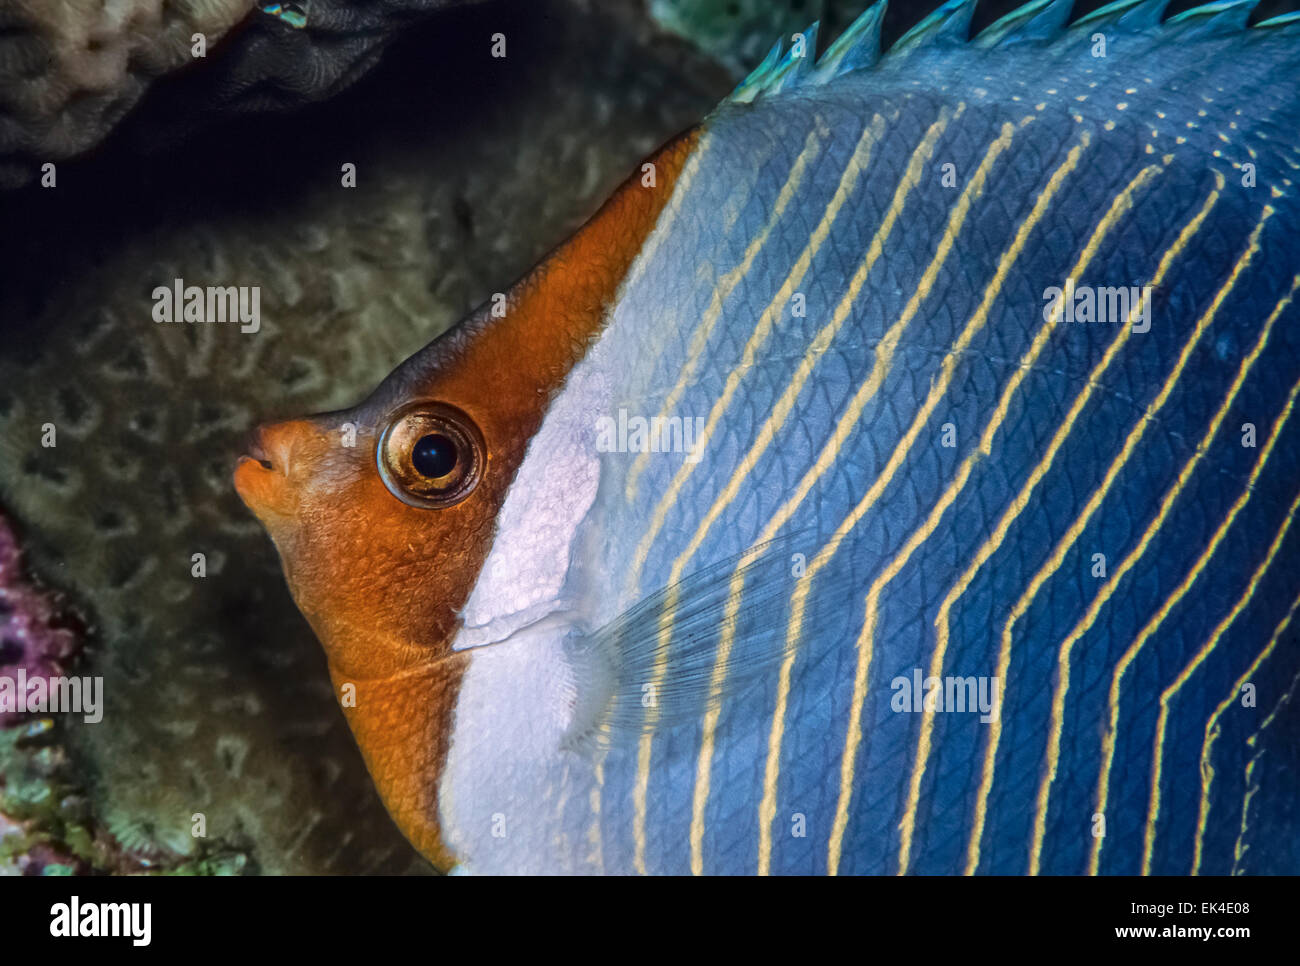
[234,134,694,867]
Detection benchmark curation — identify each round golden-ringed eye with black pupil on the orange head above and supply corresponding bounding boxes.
[376,402,485,508]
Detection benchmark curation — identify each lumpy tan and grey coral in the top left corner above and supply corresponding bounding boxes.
[0,0,499,187]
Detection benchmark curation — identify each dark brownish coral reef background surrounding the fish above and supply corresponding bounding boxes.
[0,0,1290,874]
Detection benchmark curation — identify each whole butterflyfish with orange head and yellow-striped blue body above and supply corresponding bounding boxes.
[234,0,1300,875]
